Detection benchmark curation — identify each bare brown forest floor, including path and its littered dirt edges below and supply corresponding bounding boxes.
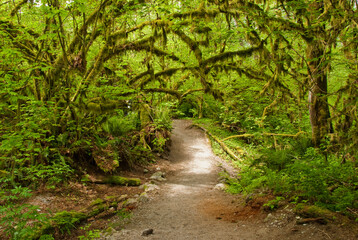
[7,120,358,240]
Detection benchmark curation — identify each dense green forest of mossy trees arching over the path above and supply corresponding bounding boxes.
[0,0,358,238]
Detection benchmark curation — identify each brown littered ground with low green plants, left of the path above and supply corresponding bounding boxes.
[0,165,155,240]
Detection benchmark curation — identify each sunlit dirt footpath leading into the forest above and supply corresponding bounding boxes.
[102,120,356,240]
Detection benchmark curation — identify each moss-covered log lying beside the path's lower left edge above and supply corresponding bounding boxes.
[29,195,128,239]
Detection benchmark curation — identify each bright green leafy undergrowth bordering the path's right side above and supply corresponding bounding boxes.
[195,119,358,221]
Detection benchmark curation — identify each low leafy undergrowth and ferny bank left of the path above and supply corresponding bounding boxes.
[0,105,171,239]
